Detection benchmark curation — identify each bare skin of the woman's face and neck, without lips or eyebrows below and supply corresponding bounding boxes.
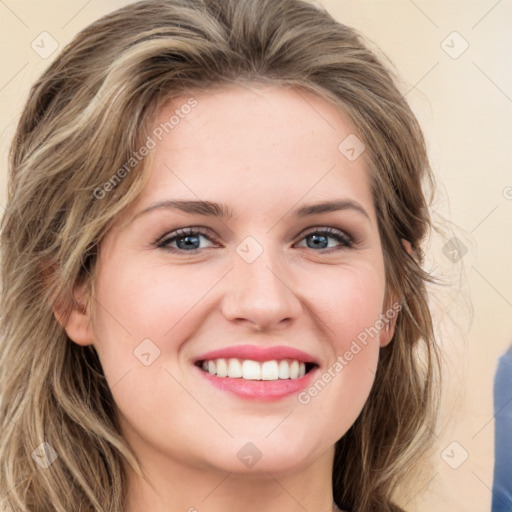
[59,84,404,512]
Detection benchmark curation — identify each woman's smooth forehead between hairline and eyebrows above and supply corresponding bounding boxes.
[132,84,372,222]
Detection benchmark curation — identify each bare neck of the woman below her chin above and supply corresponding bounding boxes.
[124,449,338,512]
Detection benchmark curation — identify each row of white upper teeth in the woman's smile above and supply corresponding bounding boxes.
[202,358,306,380]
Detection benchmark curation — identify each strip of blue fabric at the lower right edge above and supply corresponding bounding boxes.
[492,345,512,512]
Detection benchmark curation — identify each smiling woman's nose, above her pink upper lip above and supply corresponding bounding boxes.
[222,244,302,330]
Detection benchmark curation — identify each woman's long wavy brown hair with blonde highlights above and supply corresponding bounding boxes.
[0,0,439,512]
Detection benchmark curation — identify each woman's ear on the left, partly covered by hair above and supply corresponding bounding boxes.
[53,278,95,346]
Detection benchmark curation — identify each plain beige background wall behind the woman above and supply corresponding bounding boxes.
[0,0,512,512]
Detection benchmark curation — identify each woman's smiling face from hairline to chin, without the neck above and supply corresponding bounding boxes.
[67,85,400,474]
